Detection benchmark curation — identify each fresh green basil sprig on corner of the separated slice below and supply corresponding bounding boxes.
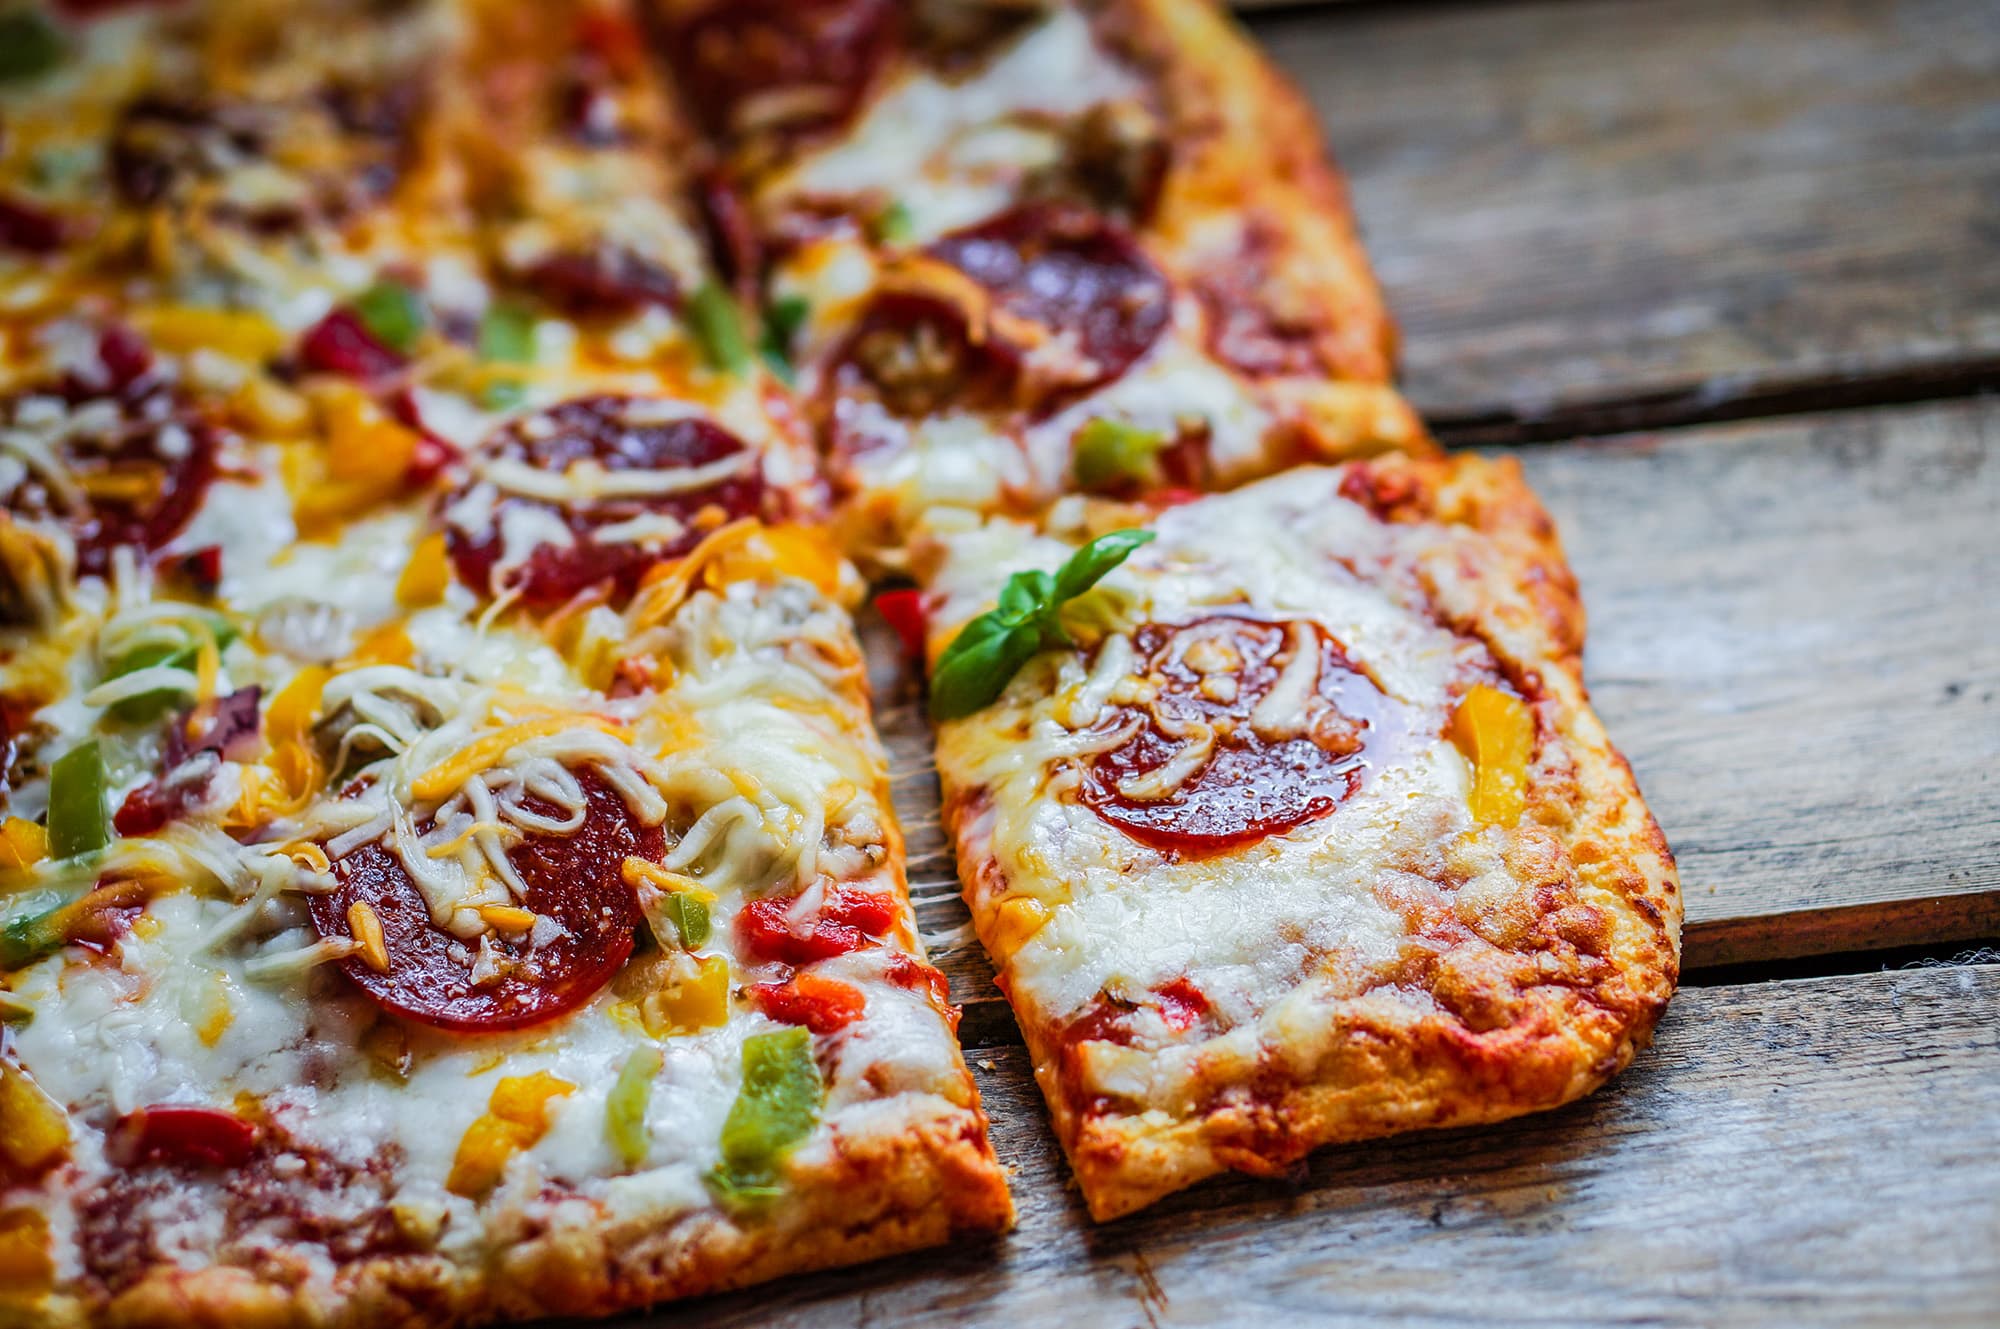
[930,530,1152,721]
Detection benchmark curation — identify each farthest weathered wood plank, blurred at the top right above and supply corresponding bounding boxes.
[1252,0,2000,442]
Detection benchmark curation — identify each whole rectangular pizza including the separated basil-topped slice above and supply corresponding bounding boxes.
[0,0,1680,1325]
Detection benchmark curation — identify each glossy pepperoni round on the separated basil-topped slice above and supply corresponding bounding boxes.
[1080,616,1394,857]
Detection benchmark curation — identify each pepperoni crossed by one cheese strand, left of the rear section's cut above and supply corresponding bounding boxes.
[444,396,776,606]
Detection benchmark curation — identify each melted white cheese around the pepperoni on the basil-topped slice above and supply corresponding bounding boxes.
[932,470,1474,1048]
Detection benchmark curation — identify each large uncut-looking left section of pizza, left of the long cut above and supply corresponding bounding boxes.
[0,0,1012,1325]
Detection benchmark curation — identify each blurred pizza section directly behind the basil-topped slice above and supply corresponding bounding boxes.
[656,0,1426,568]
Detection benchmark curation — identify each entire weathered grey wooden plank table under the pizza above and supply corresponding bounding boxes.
[624,0,2000,1329]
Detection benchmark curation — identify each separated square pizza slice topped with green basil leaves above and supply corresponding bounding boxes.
[916,456,1680,1219]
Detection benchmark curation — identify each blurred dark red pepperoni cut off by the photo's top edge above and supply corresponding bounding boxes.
[666,0,900,136]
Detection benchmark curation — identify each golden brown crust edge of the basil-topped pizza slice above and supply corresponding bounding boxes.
[944,456,1682,1219]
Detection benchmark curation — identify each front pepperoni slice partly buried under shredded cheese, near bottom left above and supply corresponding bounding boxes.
[310,773,666,1033]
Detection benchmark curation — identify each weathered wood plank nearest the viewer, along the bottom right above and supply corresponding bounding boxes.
[616,967,2000,1329]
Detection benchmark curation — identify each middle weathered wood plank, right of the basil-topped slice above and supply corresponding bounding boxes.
[872,400,2000,1016]
